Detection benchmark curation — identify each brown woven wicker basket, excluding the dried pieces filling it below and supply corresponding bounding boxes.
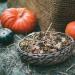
[18,32,74,65]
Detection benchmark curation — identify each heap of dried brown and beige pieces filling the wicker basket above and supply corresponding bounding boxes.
[19,32,71,54]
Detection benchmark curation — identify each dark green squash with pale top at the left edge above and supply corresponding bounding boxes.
[0,28,14,44]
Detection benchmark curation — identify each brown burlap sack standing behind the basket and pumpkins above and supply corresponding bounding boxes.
[8,0,75,31]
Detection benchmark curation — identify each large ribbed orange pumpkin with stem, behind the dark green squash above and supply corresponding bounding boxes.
[1,8,36,33]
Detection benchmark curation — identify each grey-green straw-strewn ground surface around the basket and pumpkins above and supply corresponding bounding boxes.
[0,3,75,75]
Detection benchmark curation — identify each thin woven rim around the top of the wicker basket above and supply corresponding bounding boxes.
[17,31,74,56]
